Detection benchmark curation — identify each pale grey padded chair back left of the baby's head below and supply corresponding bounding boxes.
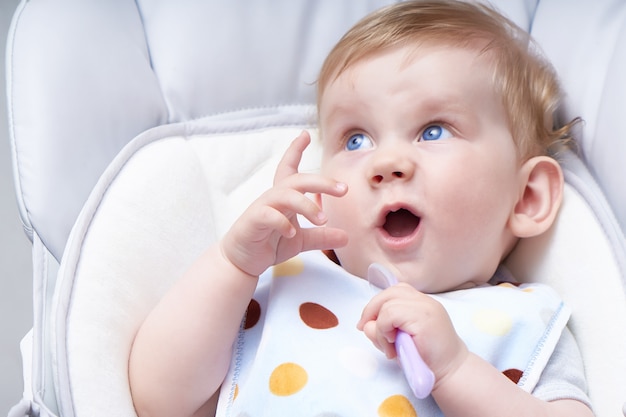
[7,0,398,259]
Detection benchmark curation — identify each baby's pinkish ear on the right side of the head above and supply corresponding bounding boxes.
[509,156,563,238]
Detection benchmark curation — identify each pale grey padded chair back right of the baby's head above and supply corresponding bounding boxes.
[531,0,626,239]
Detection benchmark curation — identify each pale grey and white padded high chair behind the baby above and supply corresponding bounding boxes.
[6,0,626,417]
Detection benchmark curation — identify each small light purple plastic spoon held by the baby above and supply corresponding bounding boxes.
[367,263,435,399]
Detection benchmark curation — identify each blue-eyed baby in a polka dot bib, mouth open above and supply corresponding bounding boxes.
[130,0,593,417]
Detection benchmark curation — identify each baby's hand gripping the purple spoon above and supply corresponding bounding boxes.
[357,283,468,387]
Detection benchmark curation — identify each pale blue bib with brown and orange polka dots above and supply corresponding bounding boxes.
[217,252,569,417]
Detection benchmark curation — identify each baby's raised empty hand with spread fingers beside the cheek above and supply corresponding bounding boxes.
[221,131,348,276]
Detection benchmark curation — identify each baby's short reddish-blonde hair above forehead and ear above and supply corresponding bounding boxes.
[317,0,577,159]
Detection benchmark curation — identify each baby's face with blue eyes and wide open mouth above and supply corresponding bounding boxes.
[320,46,523,293]
